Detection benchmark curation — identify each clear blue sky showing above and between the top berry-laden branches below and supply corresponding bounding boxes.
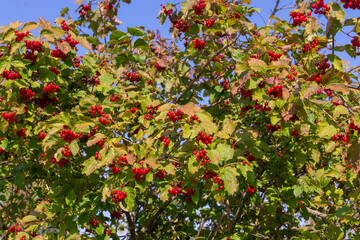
[0,0,358,65]
